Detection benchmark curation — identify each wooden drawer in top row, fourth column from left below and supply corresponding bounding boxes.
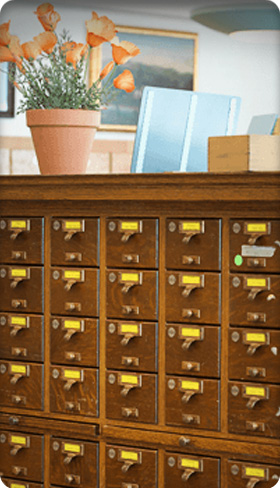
[166,219,221,271]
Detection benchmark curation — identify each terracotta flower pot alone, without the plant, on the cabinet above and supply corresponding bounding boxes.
[26,109,100,175]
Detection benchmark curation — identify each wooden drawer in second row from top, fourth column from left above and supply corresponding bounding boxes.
[166,271,220,324]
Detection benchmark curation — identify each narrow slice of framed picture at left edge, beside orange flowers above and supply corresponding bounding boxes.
[0,63,15,117]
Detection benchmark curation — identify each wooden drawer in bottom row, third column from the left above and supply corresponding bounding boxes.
[106,445,157,488]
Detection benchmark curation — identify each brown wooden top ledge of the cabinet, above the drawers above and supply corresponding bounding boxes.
[0,172,280,202]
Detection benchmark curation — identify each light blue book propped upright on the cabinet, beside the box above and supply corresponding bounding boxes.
[131,87,241,173]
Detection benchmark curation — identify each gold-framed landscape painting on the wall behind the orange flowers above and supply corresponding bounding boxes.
[89,26,198,132]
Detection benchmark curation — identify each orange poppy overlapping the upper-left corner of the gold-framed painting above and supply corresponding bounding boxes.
[86,12,117,47]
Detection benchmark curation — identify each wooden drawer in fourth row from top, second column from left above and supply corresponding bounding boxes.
[50,366,98,417]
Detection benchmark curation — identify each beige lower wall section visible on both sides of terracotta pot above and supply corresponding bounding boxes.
[0,137,134,175]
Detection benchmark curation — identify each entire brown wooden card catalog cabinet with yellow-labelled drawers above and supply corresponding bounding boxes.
[0,172,280,488]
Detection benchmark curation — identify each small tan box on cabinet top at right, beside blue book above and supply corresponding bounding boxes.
[208,135,280,173]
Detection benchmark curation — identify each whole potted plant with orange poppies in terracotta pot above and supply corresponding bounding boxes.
[0,3,140,174]
